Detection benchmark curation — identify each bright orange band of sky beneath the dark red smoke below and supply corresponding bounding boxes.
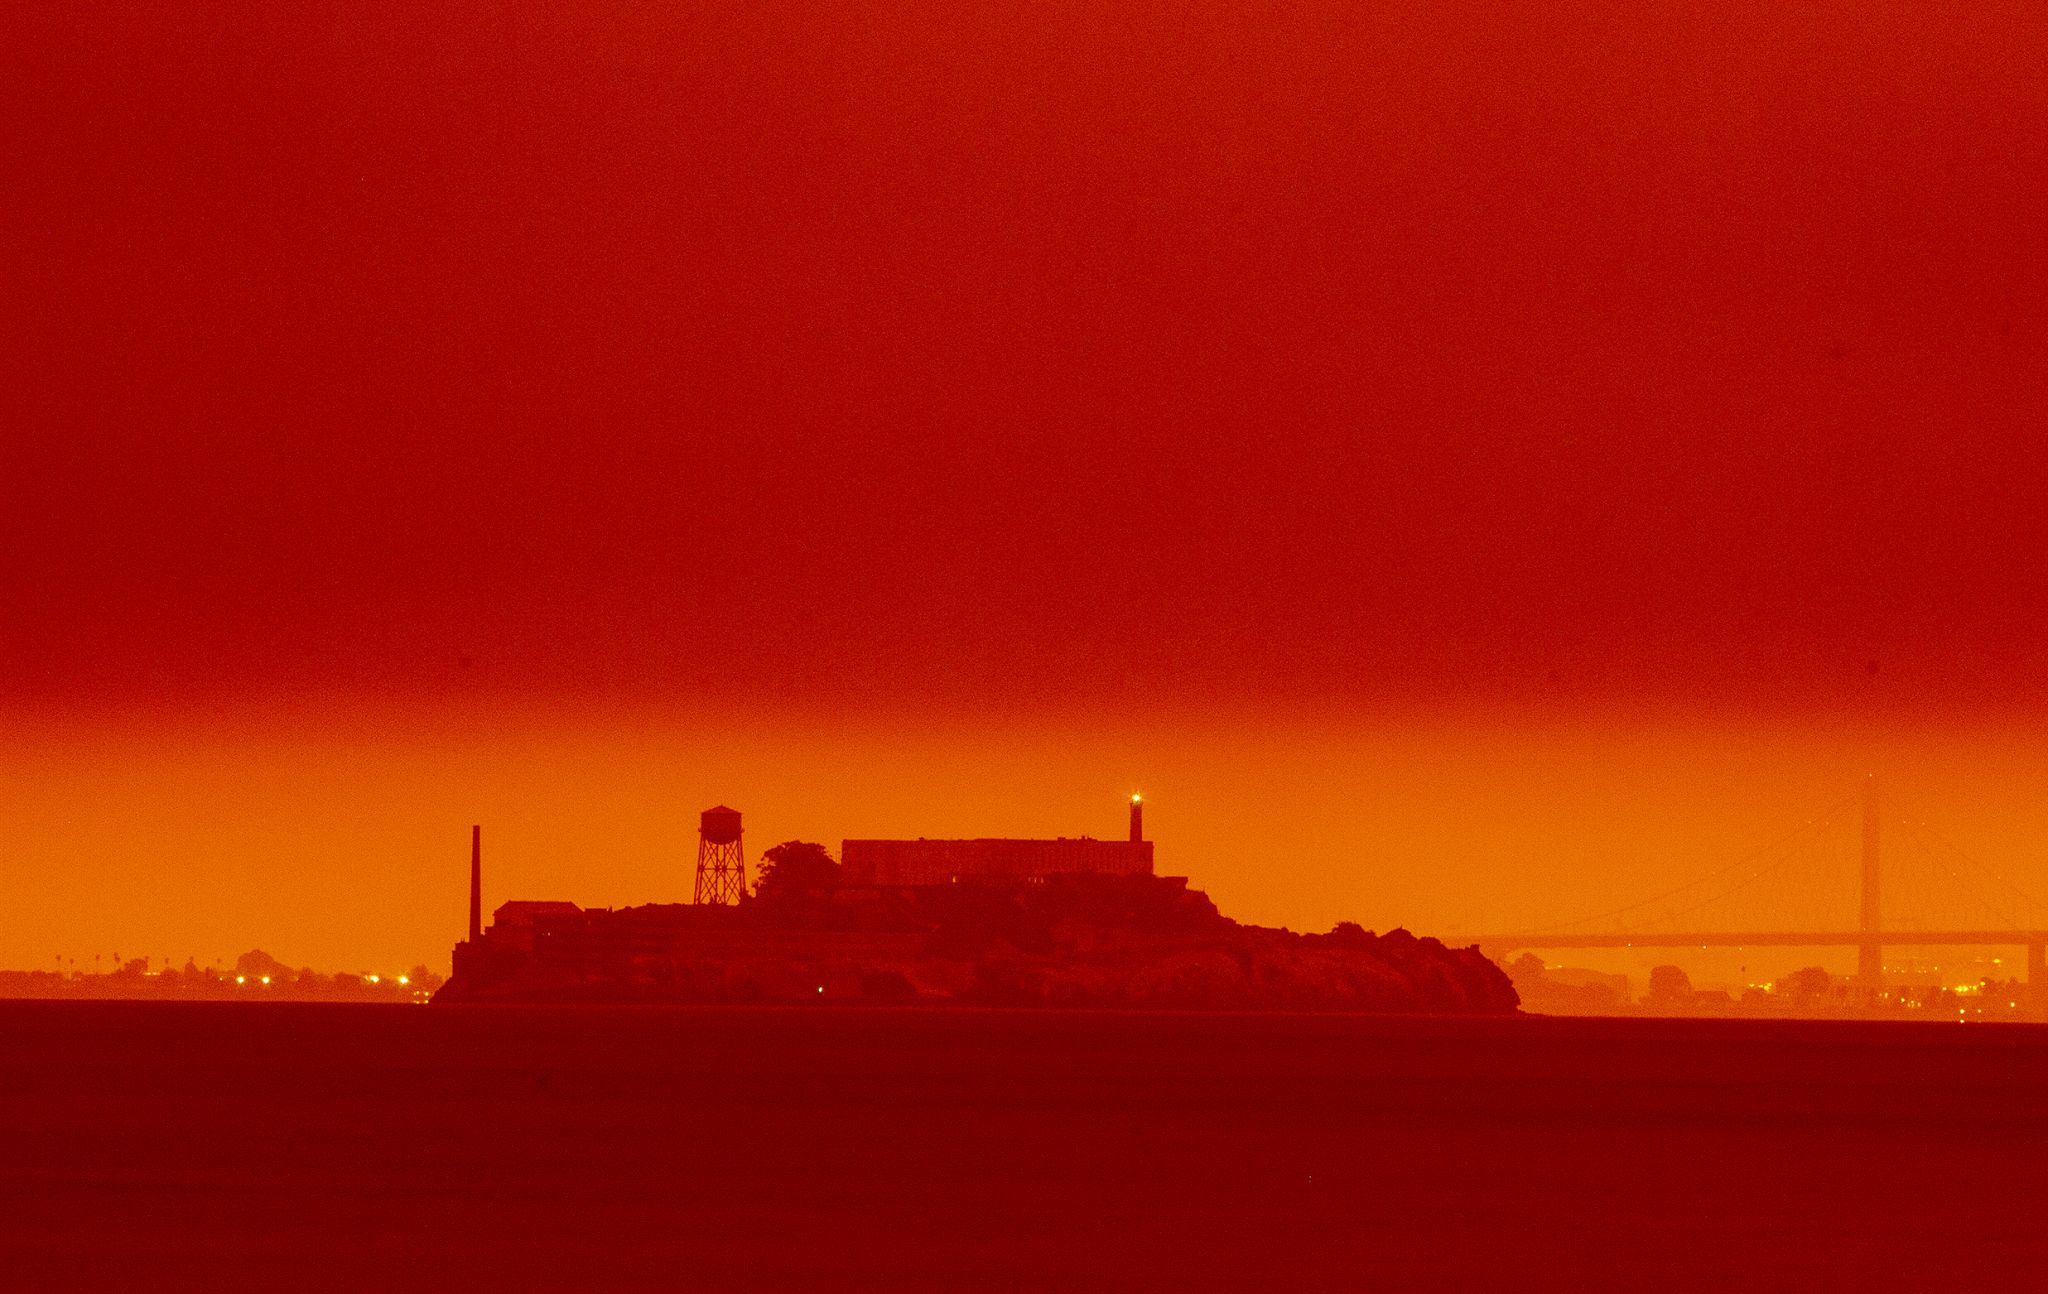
[12,706,2048,971]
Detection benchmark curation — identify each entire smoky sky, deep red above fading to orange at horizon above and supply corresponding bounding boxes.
[0,0,2048,968]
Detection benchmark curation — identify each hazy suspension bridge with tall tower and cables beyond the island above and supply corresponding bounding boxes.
[1446,778,2048,1016]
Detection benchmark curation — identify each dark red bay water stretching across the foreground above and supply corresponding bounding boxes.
[0,1001,2048,1290]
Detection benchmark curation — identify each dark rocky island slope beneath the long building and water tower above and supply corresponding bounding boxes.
[434,874,1518,1013]
